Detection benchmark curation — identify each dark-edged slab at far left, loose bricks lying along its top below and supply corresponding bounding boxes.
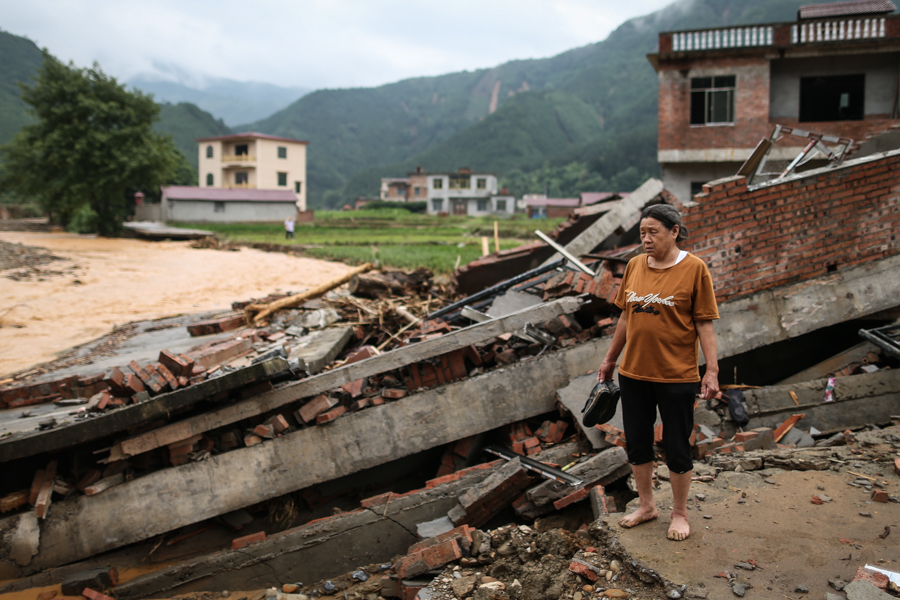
[0,358,289,463]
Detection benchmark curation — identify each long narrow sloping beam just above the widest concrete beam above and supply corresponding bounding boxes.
[114,297,582,457]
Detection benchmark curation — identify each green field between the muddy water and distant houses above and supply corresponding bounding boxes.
[173,209,563,273]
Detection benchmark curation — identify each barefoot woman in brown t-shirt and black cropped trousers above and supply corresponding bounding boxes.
[597,204,719,541]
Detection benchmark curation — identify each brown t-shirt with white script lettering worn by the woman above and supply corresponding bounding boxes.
[616,254,719,382]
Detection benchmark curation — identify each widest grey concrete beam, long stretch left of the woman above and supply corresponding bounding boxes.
[0,338,609,575]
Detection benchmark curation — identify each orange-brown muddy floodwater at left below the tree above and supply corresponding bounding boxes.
[0,231,350,379]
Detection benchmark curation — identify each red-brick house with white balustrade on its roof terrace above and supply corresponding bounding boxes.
[648,0,900,201]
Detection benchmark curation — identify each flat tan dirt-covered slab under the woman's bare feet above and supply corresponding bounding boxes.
[608,440,900,600]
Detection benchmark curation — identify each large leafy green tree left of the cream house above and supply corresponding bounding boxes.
[0,50,183,236]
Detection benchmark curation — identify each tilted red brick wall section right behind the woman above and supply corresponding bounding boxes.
[683,151,900,302]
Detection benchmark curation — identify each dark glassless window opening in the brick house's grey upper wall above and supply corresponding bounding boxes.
[800,74,866,122]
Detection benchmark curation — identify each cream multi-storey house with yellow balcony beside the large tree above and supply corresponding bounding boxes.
[197,133,308,211]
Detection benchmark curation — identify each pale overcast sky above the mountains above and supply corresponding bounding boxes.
[0,0,671,89]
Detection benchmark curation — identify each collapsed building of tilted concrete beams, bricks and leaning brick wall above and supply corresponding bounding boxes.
[0,134,900,598]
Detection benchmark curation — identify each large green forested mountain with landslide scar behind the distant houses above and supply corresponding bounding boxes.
[243,0,809,207]
